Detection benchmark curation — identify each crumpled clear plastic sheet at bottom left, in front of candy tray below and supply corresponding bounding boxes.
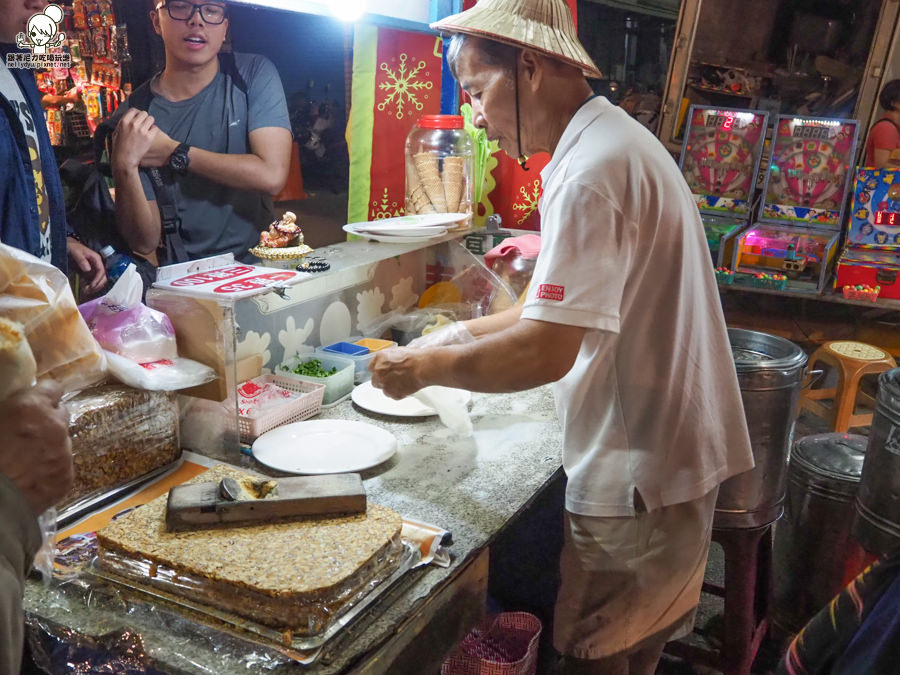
[25,579,295,675]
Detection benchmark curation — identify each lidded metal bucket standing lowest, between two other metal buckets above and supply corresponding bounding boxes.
[772,433,869,634]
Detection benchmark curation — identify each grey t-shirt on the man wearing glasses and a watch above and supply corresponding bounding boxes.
[116,54,291,260]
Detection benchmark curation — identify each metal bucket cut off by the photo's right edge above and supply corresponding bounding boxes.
[853,368,900,553]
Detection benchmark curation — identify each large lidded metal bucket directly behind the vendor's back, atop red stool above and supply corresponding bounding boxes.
[713,328,807,529]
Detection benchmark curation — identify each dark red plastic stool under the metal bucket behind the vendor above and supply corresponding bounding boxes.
[666,523,772,675]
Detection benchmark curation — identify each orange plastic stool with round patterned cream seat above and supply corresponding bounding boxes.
[800,340,897,432]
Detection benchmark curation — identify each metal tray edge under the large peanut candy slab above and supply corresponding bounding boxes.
[83,539,421,651]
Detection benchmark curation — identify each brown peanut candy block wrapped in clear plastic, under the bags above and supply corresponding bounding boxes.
[59,385,181,509]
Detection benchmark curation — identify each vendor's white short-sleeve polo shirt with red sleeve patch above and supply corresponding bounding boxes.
[522,98,753,517]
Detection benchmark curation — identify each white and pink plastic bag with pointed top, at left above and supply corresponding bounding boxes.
[78,265,178,363]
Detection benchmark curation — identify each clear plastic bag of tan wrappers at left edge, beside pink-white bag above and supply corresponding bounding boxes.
[0,244,106,392]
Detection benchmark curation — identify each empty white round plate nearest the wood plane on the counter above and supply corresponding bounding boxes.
[253,420,397,474]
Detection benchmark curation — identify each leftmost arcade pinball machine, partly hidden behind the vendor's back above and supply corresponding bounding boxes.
[679,106,769,267]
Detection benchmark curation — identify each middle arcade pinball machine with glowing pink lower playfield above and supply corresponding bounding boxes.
[734,115,859,293]
